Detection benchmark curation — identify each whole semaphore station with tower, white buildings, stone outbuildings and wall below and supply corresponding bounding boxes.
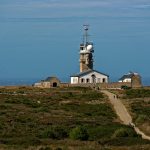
[34,25,142,89]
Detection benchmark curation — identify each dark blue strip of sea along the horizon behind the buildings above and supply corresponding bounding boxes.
[0,77,150,86]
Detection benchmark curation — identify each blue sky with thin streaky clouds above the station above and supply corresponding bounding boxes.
[0,0,150,82]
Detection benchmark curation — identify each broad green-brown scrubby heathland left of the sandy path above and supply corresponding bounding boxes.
[0,87,150,150]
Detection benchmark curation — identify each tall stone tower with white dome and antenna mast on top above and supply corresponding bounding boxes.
[80,25,94,72]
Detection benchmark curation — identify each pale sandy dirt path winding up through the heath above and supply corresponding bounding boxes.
[102,90,150,140]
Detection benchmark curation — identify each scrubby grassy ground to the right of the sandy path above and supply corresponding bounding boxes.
[115,88,150,135]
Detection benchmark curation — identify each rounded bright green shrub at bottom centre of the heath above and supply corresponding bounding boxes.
[69,126,89,141]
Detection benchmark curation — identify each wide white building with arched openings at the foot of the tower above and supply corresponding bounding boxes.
[71,70,109,84]
